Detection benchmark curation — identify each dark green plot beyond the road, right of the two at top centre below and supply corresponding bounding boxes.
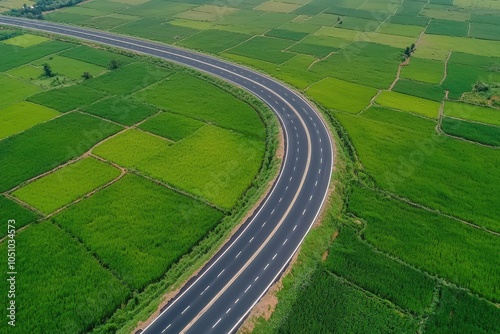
[227,36,293,64]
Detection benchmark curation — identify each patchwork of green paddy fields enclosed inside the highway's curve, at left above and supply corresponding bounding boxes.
[0,30,276,333]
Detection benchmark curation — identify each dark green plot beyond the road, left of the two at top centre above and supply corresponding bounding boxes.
[177,30,251,53]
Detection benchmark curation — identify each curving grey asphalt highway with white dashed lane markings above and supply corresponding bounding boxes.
[0,16,334,334]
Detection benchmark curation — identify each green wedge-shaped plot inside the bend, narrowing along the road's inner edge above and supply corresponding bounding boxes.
[134,73,265,139]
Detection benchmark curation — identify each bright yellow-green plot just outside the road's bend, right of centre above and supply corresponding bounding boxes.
[307,78,377,113]
